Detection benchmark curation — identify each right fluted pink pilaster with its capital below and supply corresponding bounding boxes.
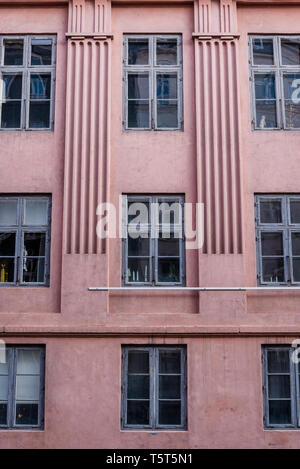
[193,0,242,254]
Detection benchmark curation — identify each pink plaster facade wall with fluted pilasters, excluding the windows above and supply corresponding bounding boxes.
[0,0,300,448]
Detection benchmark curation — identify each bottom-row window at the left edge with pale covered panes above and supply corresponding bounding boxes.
[0,346,45,430]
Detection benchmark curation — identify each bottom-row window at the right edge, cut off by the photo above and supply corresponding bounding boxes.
[263,346,300,428]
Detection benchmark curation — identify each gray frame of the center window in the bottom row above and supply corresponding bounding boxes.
[121,345,187,430]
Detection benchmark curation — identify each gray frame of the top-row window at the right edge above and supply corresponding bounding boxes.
[248,35,300,132]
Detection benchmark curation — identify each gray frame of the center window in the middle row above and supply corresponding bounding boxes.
[122,195,186,287]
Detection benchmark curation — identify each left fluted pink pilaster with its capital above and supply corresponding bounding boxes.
[64,0,112,254]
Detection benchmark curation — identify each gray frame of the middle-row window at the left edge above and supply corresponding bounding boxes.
[0,195,52,288]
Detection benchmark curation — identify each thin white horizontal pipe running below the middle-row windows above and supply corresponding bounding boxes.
[88,286,300,291]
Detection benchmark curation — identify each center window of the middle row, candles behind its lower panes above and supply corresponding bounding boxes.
[123,196,185,286]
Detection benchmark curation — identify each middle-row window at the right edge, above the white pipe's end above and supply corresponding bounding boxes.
[255,195,300,285]
